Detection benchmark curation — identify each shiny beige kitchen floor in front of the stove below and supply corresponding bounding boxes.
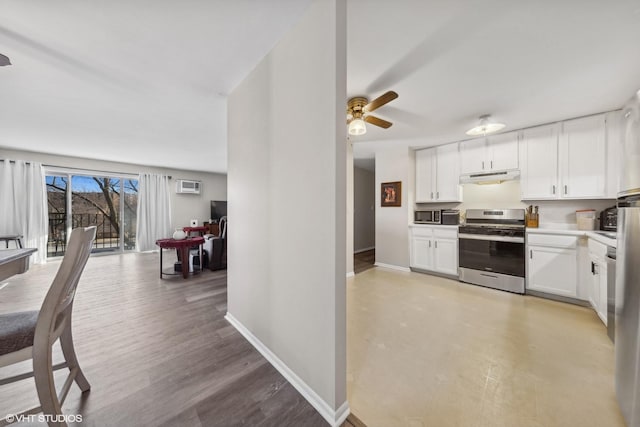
[347,267,624,427]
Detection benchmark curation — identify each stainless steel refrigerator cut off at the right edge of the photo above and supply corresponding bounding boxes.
[615,90,640,427]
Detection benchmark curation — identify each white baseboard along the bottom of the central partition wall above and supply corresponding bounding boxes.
[224,312,350,427]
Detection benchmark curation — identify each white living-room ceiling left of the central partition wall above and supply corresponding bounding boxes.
[0,0,310,173]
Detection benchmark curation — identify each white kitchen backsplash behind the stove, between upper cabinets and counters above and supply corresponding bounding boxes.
[416,181,616,227]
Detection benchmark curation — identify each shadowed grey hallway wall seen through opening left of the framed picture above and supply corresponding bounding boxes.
[351,167,376,252]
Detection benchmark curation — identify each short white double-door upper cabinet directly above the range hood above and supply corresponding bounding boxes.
[460,132,518,175]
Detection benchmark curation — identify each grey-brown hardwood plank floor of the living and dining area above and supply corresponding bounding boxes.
[0,252,361,427]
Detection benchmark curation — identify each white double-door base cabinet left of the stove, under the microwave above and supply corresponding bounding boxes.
[410,226,458,276]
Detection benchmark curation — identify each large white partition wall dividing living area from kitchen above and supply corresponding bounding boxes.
[227,0,348,424]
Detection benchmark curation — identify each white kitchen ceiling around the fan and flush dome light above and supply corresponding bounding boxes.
[348,0,640,158]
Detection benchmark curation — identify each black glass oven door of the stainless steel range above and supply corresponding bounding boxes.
[458,234,525,277]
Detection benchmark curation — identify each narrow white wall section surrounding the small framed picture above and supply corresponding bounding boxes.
[375,148,415,269]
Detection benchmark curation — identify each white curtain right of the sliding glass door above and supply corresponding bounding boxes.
[136,174,172,252]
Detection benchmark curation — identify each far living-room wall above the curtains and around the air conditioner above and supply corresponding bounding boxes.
[0,147,227,229]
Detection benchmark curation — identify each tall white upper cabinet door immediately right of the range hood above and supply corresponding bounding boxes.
[520,124,559,200]
